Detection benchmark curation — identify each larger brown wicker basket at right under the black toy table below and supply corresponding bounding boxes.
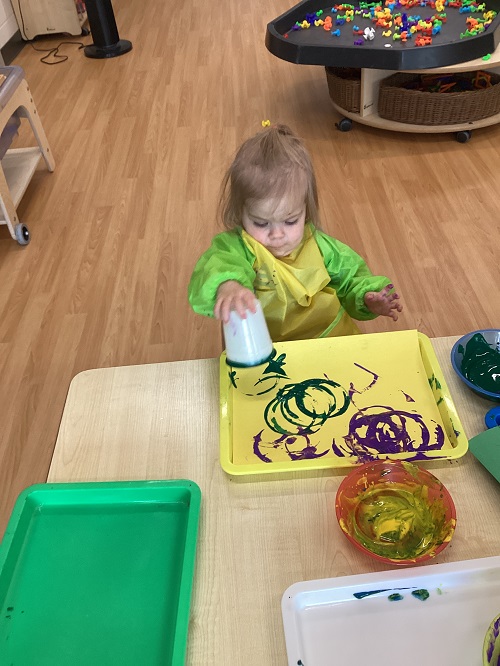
[378,72,500,125]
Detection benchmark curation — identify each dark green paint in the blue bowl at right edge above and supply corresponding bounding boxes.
[458,333,500,393]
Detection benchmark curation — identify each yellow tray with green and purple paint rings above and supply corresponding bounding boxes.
[220,331,468,475]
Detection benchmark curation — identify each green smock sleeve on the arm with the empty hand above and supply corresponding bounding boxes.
[315,230,390,320]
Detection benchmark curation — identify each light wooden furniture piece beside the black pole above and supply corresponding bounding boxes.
[11,0,87,41]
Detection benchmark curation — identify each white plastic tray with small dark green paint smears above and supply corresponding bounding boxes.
[281,557,500,666]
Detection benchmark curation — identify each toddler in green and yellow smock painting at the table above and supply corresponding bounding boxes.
[189,125,402,342]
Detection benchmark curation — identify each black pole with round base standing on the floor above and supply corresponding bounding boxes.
[84,0,132,58]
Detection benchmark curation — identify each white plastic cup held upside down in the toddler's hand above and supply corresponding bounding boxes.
[223,301,273,367]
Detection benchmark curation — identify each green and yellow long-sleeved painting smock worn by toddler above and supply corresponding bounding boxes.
[188,223,389,342]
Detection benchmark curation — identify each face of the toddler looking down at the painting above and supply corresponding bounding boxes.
[242,195,306,257]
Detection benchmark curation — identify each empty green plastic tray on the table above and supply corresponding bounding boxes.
[0,481,201,666]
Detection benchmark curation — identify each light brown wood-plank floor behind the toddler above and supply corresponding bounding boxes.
[0,0,500,531]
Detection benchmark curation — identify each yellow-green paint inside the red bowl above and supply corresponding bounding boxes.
[352,483,452,560]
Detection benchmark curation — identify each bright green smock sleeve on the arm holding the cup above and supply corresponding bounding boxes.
[188,231,255,317]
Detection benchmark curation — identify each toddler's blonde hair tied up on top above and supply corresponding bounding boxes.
[219,125,319,229]
